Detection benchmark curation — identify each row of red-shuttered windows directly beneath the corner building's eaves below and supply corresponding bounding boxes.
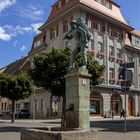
[50,14,124,40]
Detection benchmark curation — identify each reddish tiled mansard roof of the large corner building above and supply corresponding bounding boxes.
[39,0,128,30]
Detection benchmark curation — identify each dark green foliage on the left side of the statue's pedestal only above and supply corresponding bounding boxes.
[30,48,71,96]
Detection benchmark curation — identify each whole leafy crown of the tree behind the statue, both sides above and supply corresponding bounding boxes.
[30,48,104,96]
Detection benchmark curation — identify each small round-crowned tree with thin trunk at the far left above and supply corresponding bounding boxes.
[0,74,33,122]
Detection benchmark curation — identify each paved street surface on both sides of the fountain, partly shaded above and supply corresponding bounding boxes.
[0,117,140,140]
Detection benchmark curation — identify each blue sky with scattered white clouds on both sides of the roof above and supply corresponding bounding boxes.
[0,0,140,68]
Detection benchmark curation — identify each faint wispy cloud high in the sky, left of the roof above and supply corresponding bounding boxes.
[20,5,44,20]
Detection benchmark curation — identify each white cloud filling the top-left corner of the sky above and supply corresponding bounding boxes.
[0,0,16,13]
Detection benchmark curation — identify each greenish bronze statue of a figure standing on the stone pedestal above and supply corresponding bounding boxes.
[64,18,92,69]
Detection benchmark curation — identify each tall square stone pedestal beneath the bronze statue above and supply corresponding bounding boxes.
[65,68,91,129]
